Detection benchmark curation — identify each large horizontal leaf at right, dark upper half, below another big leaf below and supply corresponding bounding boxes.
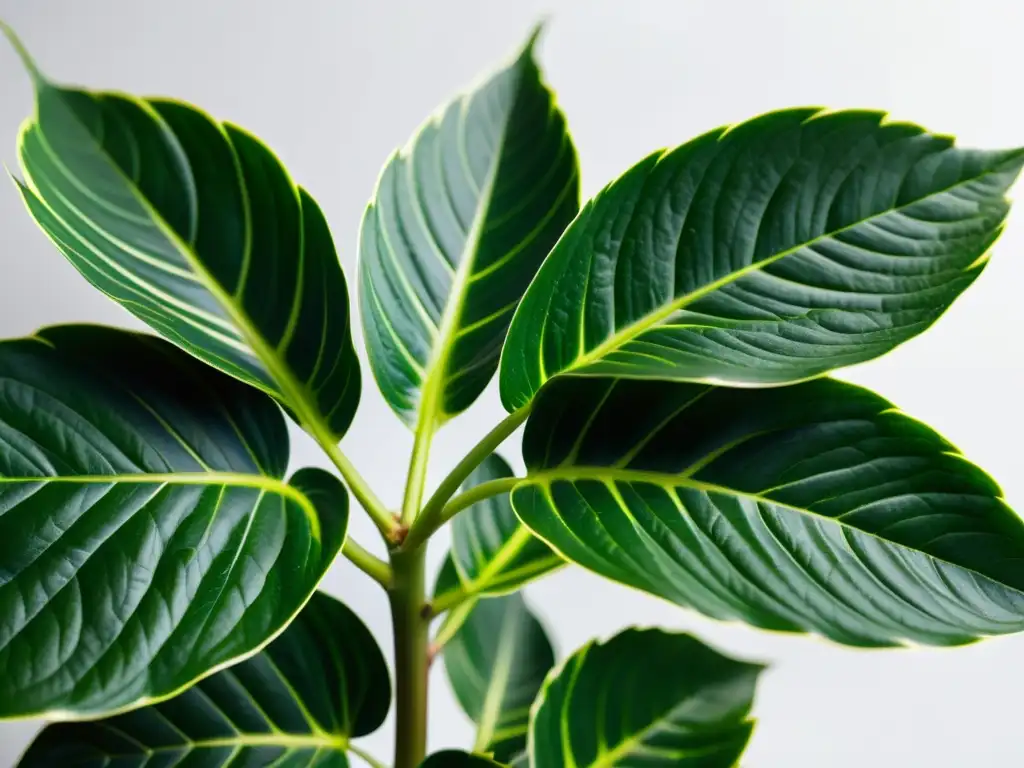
[512,378,1024,646]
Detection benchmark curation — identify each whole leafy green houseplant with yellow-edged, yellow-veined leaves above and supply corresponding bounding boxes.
[0,13,1022,766]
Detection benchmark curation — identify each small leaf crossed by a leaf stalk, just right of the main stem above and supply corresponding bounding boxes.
[452,454,565,595]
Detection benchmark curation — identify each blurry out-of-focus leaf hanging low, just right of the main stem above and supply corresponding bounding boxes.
[443,594,555,762]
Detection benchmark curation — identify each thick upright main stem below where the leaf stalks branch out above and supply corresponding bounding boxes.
[391,549,429,768]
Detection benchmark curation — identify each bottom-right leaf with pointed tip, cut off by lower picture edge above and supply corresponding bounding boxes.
[529,629,763,768]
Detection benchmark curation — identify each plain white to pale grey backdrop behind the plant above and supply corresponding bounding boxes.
[0,0,1024,768]
